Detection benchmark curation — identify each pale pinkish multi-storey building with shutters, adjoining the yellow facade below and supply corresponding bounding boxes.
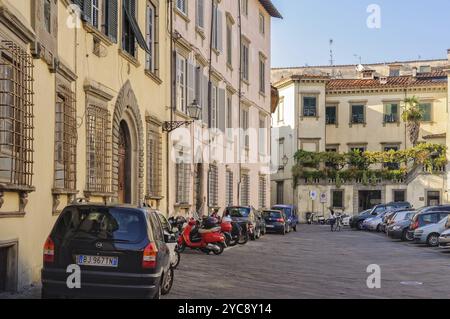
[167,0,281,218]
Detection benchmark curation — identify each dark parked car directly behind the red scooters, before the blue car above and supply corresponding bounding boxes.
[225,206,263,240]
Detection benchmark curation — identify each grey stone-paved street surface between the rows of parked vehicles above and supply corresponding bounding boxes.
[0,225,450,299]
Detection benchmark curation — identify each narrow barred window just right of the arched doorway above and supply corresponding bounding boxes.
[147,123,162,197]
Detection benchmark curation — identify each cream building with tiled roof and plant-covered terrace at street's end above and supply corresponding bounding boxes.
[271,55,450,220]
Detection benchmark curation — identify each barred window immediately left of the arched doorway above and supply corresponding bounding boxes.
[86,105,111,193]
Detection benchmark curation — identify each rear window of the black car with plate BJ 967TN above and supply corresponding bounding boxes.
[56,207,146,242]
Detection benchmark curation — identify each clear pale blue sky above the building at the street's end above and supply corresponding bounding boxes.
[272,0,450,67]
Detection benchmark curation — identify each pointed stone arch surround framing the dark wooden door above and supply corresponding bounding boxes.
[112,81,144,204]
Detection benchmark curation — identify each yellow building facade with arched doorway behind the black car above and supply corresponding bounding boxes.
[0,0,170,291]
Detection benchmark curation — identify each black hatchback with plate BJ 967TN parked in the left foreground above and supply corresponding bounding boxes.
[42,204,176,299]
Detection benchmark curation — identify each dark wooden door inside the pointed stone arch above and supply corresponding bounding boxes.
[118,121,132,204]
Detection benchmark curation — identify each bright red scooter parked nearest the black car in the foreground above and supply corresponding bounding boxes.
[178,218,226,255]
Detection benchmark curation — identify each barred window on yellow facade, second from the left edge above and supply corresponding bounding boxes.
[54,85,77,191]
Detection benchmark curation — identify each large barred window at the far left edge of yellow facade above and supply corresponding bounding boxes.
[0,40,34,186]
